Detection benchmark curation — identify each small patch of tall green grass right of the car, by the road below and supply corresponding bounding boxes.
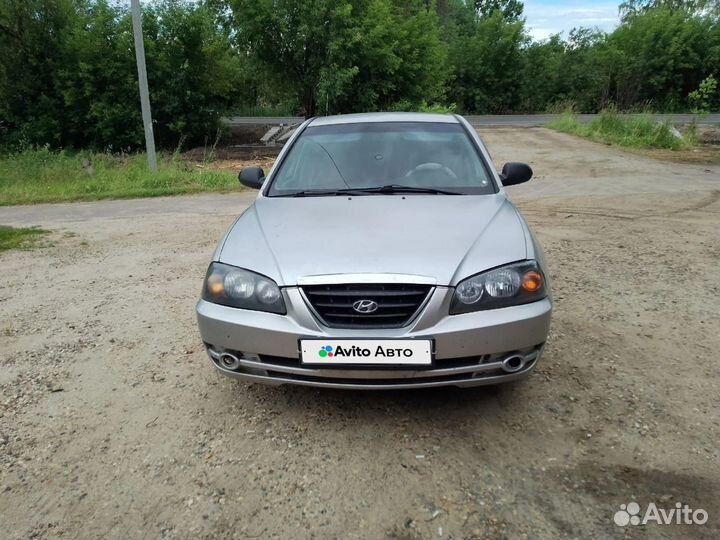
[548,111,695,150]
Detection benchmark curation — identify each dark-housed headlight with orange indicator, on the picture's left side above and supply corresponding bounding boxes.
[202,262,286,315]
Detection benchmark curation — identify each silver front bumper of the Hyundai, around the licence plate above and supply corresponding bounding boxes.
[197,287,552,389]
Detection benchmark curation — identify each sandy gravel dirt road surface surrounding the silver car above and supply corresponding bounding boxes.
[0,128,720,539]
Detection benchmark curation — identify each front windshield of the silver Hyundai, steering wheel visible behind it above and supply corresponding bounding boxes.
[267,122,495,196]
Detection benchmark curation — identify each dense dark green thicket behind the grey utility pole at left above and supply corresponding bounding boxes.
[0,0,242,151]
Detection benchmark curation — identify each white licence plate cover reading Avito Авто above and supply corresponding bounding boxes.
[300,339,432,366]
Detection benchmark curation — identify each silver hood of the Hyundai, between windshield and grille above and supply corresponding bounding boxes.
[219,193,527,286]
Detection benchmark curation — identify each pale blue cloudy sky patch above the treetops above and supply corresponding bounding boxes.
[524,0,619,40]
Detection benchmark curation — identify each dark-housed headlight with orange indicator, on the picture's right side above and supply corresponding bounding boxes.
[450,261,547,315]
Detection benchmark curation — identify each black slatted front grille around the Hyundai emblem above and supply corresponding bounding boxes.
[303,283,431,328]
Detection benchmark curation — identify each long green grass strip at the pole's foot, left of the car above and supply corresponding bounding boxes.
[0,148,239,205]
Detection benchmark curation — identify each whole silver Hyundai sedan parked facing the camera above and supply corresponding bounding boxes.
[197,113,552,389]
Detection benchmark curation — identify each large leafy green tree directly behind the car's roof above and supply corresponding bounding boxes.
[231,0,446,116]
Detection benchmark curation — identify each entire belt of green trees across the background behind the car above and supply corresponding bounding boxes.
[0,0,720,152]
